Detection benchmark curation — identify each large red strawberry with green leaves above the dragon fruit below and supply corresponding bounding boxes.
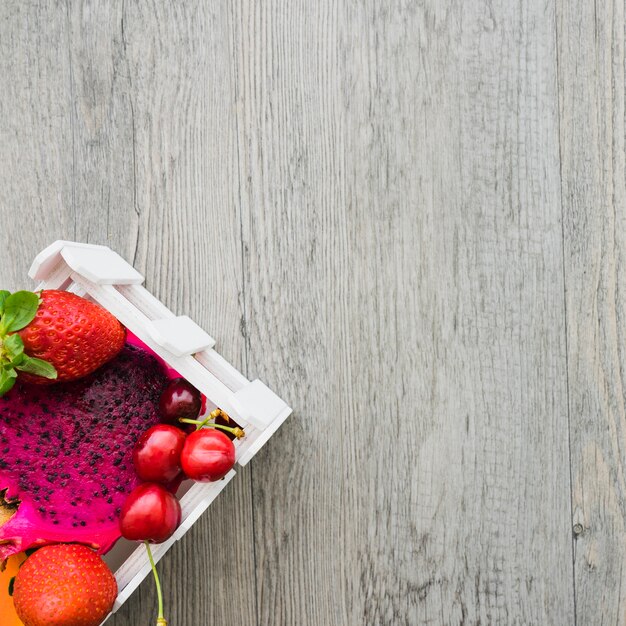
[0,290,125,395]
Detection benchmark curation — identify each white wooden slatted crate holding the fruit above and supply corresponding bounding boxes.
[29,241,291,621]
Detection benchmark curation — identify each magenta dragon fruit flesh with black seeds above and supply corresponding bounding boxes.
[0,345,168,563]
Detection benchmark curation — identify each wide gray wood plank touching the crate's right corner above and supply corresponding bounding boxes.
[235,1,574,626]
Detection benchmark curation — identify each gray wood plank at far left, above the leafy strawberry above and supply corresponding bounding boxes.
[0,2,74,289]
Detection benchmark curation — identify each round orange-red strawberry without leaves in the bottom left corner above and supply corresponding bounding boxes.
[13,544,117,626]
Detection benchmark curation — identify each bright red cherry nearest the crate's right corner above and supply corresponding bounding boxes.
[180,428,235,483]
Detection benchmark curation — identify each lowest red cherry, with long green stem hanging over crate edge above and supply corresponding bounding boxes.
[120,483,182,543]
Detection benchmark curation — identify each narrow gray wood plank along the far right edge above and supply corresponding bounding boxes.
[557,1,626,624]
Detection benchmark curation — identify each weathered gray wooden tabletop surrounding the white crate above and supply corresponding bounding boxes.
[0,0,626,626]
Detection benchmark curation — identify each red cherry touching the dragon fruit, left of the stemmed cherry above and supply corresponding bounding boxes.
[133,424,187,483]
